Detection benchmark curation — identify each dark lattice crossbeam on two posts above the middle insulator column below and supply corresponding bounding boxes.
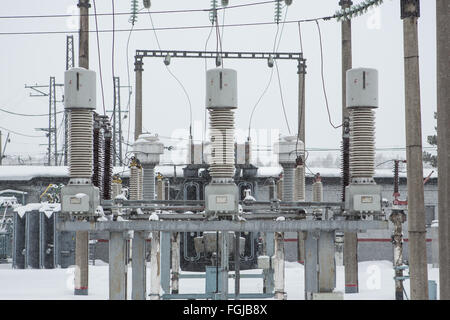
[135,50,305,61]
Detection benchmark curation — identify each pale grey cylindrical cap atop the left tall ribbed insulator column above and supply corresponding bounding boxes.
[64,68,96,109]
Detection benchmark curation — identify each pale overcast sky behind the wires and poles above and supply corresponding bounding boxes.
[0,0,436,165]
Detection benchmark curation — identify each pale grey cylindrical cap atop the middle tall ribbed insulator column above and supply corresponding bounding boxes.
[206,68,237,109]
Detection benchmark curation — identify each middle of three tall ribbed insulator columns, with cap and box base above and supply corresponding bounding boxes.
[205,68,239,216]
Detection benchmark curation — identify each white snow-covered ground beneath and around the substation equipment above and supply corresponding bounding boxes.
[0,260,439,300]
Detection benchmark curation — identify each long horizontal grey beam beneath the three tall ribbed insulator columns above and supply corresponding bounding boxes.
[57,220,388,232]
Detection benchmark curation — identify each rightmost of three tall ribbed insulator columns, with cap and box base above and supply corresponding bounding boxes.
[345,68,382,214]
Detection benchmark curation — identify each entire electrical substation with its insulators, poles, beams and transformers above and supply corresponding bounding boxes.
[0,0,450,300]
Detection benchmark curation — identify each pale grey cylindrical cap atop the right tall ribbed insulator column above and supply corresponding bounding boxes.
[347,68,378,108]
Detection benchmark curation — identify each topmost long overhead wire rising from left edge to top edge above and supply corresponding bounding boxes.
[0,0,275,19]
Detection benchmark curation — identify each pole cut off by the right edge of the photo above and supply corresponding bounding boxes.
[436,0,450,300]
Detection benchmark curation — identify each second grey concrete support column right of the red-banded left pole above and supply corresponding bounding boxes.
[131,231,147,300]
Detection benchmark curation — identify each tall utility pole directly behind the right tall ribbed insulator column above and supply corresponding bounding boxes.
[339,0,359,293]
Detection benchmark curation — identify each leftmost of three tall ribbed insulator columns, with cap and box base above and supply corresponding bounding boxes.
[61,68,100,216]
